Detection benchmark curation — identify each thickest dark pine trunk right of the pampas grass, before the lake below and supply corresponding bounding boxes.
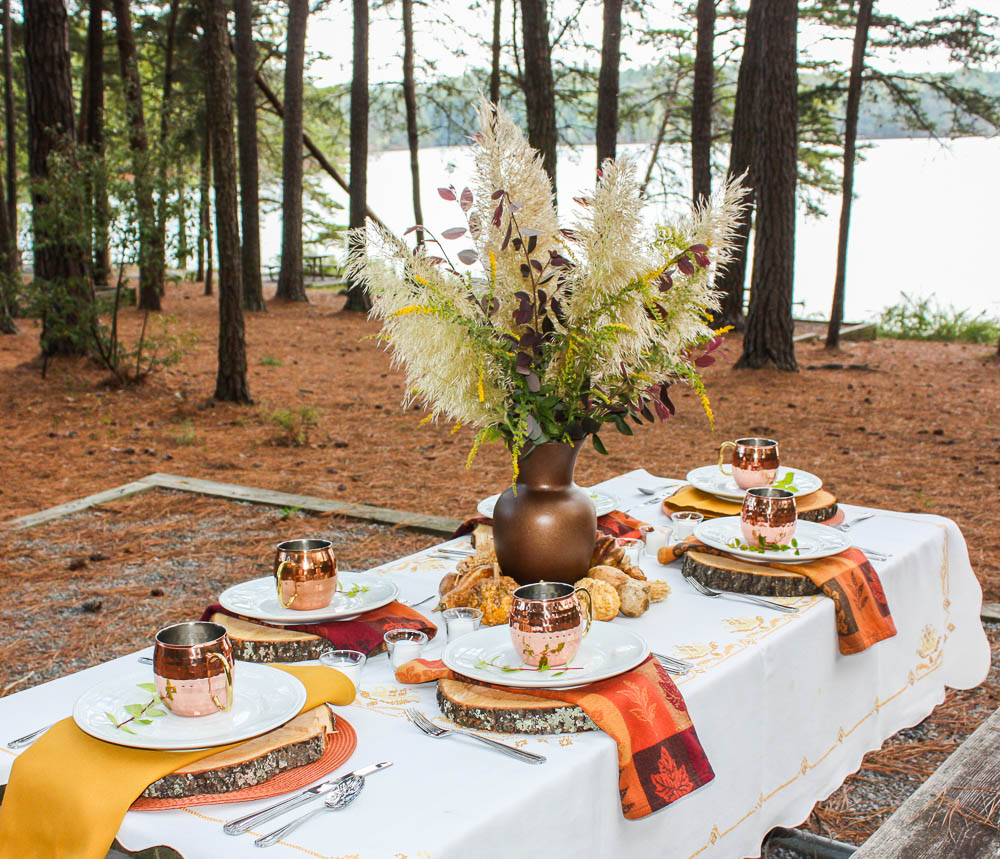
[736,0,798,370]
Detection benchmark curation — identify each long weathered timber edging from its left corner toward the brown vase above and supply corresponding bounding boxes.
[143,473,462,534]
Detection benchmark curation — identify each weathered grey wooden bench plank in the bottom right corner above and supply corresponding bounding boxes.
[853,710,1000,859]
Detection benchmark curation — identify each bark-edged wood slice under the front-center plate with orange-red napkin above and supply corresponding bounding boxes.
[437,679,600,734]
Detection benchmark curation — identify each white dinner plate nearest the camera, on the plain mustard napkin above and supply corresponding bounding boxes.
[73,662,306,751]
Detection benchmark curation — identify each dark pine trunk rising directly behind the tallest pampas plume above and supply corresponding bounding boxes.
[521,0,558,195]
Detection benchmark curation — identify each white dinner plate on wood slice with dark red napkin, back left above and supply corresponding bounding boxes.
[219,573,399,625]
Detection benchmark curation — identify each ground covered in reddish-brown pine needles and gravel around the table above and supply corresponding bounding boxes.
[0,284,1000,844]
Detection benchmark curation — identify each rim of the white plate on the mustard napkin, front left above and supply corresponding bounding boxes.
[73,662,308,752]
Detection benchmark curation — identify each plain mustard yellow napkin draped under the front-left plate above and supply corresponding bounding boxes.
[0,665,354,859]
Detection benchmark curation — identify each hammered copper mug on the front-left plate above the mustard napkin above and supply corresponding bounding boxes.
[153,621,233,716]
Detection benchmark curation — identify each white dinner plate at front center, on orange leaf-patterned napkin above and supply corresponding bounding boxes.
[441,621,649,689]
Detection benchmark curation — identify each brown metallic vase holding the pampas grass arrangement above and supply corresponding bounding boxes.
[493,443,597,584]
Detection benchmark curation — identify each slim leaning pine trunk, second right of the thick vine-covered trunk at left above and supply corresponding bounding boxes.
[112,0,163,310]
